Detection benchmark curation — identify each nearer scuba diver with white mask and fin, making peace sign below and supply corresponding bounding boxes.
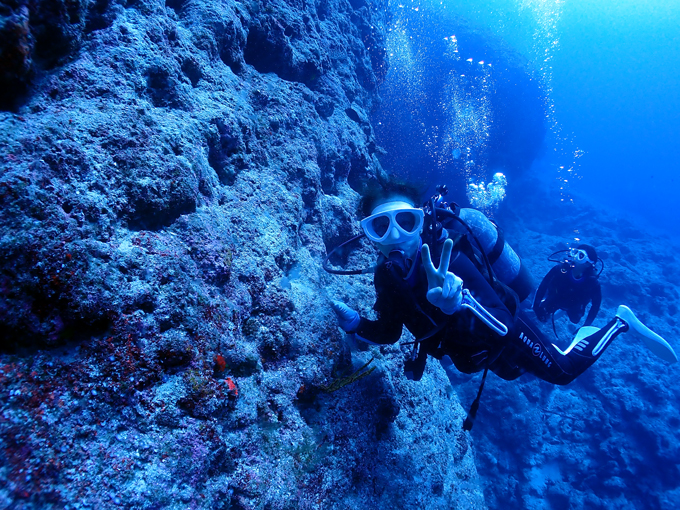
[324,181,677,430]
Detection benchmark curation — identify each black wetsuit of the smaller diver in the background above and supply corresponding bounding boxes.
[534,262,602,326]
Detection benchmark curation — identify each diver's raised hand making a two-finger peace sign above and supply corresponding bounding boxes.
[421,239,463,315]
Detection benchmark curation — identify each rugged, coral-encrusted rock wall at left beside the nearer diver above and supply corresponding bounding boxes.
[0,0,485,509]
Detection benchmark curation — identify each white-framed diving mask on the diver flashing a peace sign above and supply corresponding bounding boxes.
[361,201,425,245]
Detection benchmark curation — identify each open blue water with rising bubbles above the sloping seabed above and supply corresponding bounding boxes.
[374,0,680,236]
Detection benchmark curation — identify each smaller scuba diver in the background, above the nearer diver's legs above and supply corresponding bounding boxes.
[533,244,604,326]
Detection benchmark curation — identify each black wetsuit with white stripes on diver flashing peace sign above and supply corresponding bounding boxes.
[356,244,627,384]
